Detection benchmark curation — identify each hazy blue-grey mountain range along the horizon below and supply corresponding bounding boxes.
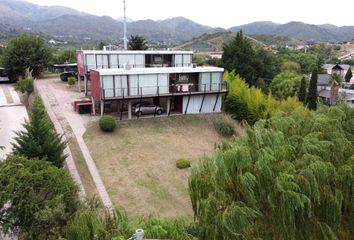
[0,0,354,44]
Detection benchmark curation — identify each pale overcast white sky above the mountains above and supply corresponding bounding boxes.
[26,0,354,28]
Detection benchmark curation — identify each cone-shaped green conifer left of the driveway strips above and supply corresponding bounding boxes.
[12,97,66,167]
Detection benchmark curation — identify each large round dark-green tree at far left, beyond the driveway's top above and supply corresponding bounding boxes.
[2,34,52,80]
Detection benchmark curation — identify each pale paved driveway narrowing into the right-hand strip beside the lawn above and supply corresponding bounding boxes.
[36,79,113,209]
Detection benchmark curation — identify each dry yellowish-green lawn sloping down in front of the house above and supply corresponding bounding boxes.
[84,115,227,217]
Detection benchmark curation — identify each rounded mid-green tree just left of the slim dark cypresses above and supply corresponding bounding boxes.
[270,71,301,99]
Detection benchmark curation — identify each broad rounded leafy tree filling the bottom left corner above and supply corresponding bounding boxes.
[0,156,79,239]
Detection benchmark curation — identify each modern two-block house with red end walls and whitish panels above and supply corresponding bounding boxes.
[77,51,227,119]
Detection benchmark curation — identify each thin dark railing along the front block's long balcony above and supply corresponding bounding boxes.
[102,83,227,99]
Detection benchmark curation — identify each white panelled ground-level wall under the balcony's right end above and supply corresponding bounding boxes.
[183,94,222,114]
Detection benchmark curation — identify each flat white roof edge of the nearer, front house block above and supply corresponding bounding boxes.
[92,67,224,76]
